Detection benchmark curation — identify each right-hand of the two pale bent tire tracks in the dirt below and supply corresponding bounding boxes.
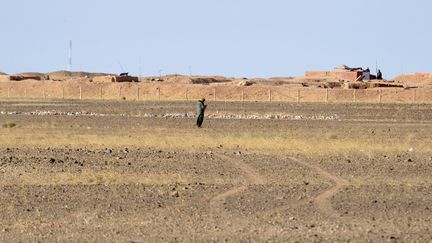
[290,157,349,217]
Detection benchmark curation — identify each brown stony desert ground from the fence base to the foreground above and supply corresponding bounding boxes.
[0,99,432,242]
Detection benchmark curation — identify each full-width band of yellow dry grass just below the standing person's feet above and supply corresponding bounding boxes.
[0,129,432,155]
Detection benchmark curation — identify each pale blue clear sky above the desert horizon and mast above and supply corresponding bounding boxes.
[0,0,432,77]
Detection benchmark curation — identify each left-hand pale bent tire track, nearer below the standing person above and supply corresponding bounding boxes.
[210,154,265,211]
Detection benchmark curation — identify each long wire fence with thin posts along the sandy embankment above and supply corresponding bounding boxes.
[0,81,432,103]
